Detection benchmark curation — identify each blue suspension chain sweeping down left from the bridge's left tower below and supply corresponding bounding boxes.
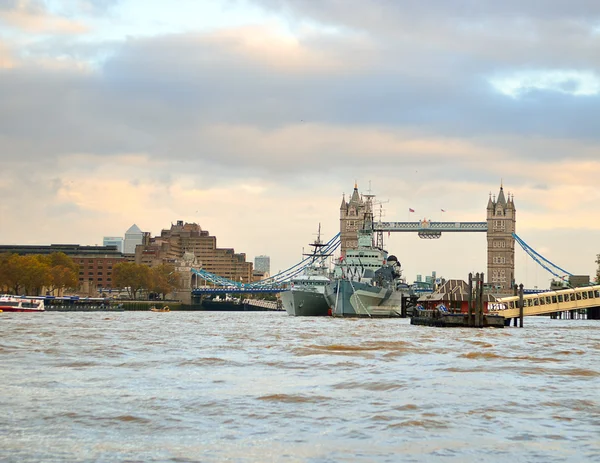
[192,233,341,289]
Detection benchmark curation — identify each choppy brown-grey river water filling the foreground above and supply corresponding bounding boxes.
[0,312,600,463]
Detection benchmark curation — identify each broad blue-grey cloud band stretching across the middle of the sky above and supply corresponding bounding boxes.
[0,11,600,178]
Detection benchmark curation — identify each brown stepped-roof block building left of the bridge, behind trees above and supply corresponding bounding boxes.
[135,220,253,283]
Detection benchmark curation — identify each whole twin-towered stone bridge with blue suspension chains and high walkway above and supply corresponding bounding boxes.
[186,184,572,304]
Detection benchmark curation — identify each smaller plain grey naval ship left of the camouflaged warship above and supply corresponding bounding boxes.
[281,226,331,317]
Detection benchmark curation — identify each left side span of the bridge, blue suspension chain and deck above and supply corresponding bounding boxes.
[191,233,340,296]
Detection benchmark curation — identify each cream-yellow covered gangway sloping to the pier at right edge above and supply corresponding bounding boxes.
[490,285,600,318]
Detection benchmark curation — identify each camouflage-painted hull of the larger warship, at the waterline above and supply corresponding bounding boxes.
[325,280,403,317]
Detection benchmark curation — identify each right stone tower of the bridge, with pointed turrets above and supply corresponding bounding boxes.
[487,185,517,293]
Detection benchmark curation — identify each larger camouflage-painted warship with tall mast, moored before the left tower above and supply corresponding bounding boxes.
[325,215,410,317]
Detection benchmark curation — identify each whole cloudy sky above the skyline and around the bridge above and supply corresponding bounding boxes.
[0,0,600,288]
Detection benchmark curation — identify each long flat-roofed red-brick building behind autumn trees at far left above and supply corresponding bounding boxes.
[0,244,126,295]
